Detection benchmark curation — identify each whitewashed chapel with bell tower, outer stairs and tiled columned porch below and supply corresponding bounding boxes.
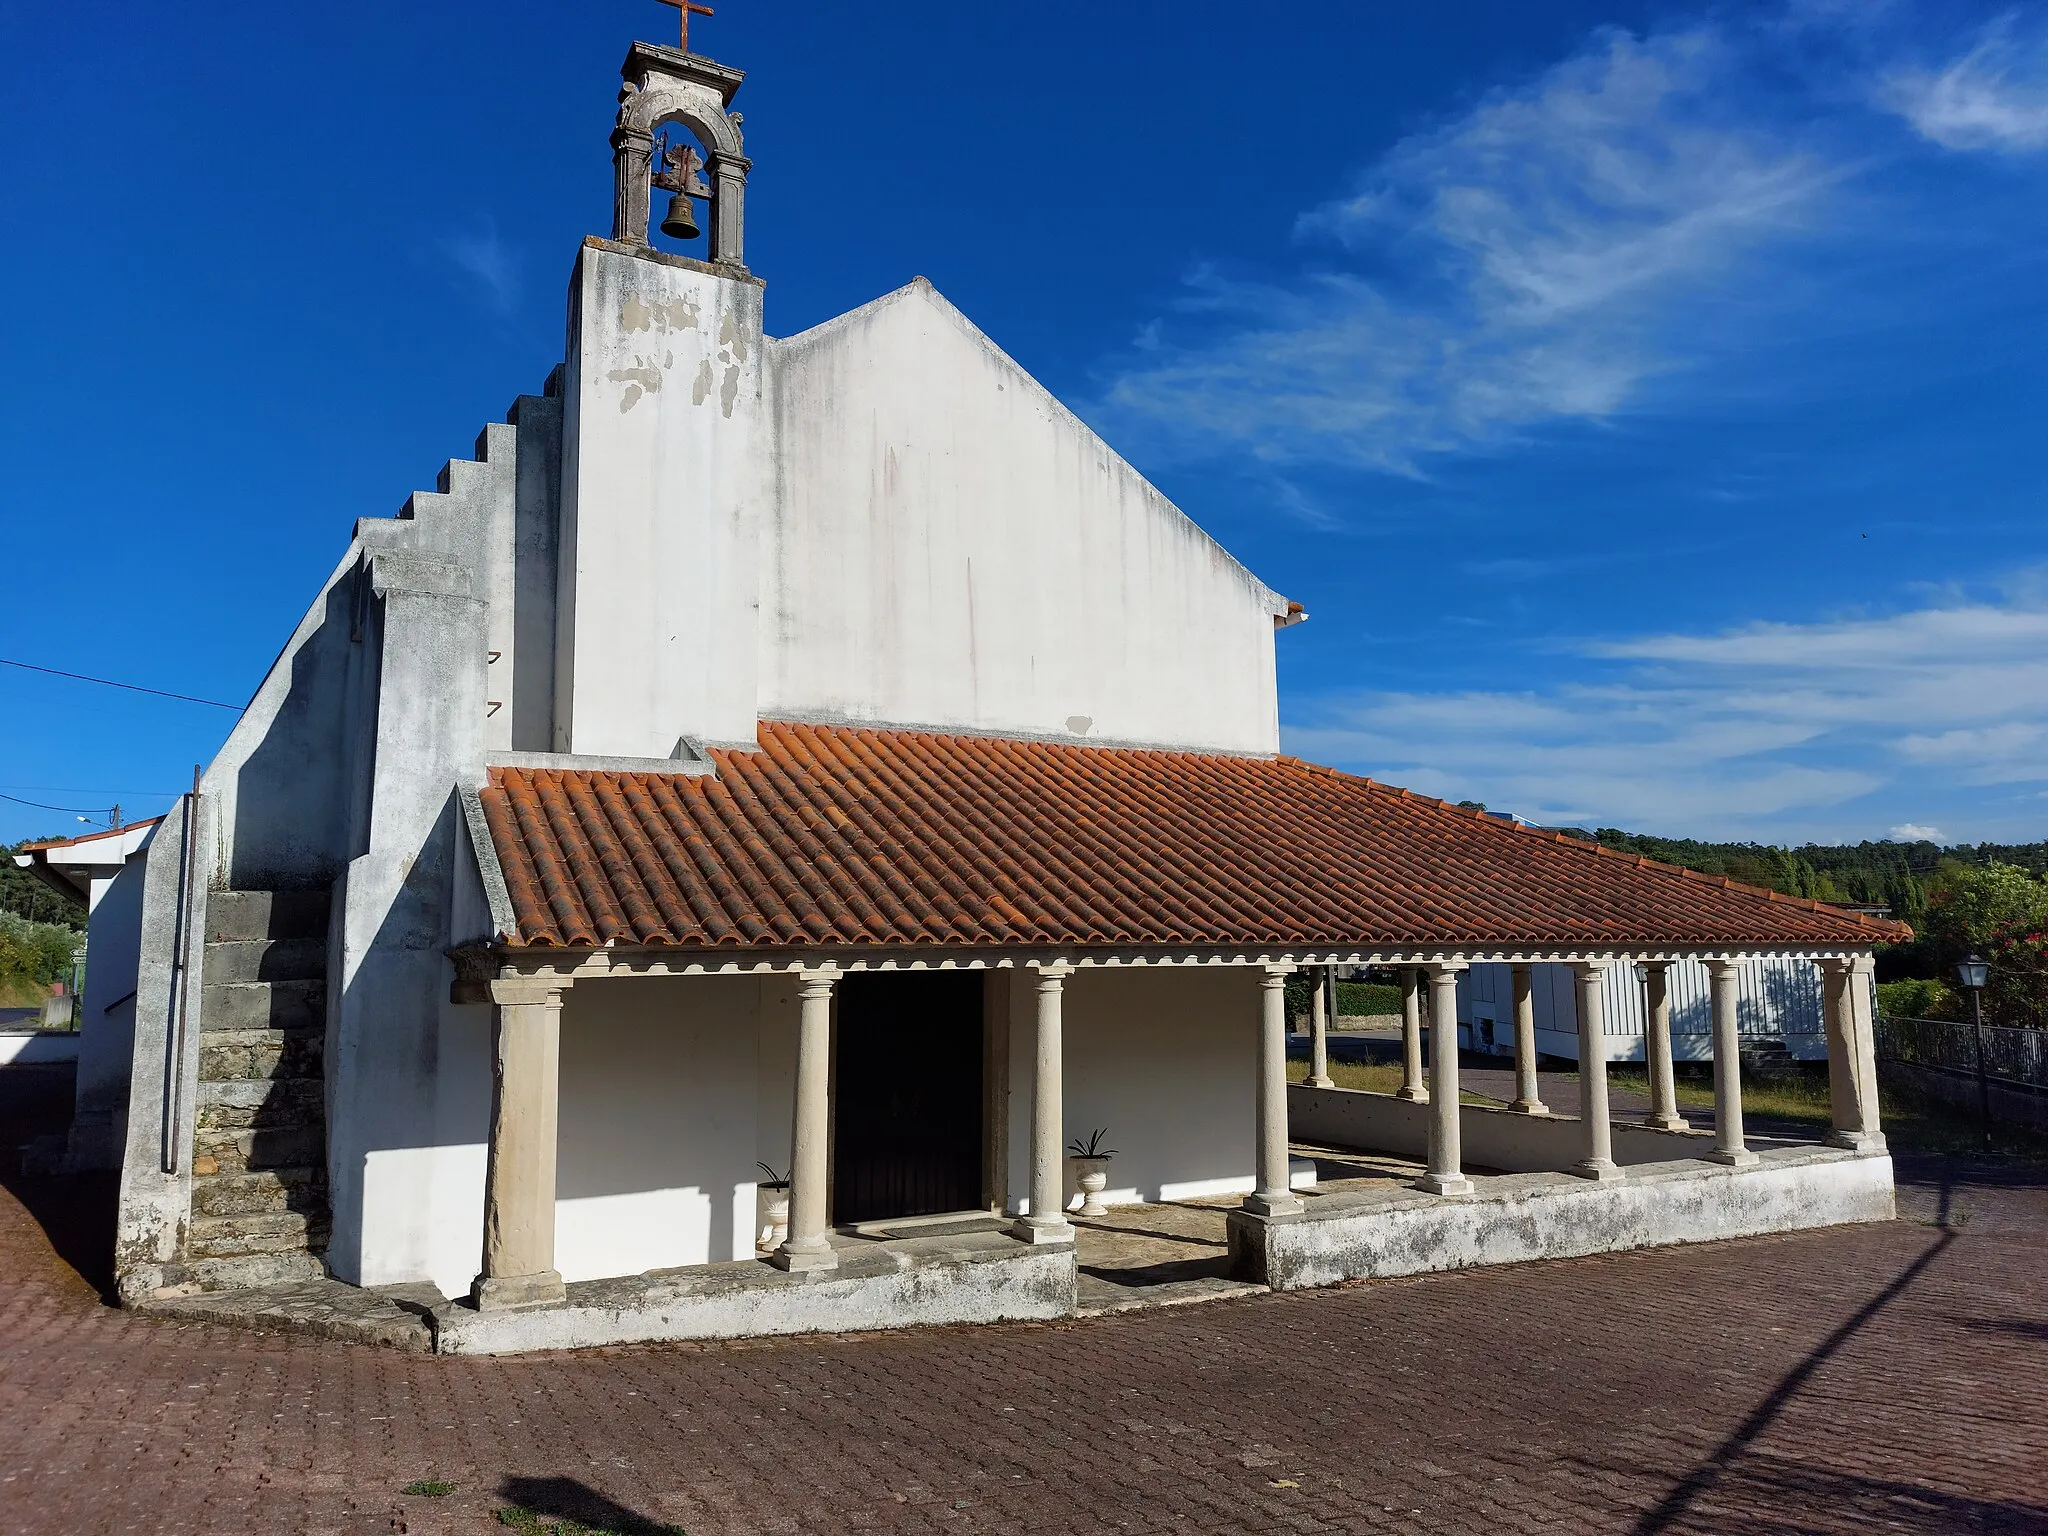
[88,20,1890,1350]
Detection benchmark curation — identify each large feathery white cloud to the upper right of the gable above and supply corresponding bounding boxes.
[1104,29,1843,471]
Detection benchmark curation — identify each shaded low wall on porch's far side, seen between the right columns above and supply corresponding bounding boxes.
[1286,1083,1714,1174]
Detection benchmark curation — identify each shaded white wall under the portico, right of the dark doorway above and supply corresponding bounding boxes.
[1006,967,1260,1212]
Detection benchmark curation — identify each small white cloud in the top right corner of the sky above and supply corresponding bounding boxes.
[1878,12,2048,154]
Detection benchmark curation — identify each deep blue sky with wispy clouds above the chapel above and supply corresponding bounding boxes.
[0,0,2048,842]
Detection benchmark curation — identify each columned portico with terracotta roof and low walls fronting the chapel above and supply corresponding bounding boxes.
[428,723,1890,1348]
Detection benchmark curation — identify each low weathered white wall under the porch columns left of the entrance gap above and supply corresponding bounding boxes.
[432,1233,1075,1354]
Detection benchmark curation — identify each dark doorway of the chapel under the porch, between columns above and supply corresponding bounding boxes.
[831,971,983,1225]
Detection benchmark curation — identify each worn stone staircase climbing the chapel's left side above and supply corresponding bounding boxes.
[184,891,330,1290]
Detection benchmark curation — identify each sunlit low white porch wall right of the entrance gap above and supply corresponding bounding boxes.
[1229,1147,1894,1290]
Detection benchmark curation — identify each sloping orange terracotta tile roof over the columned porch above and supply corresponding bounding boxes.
[483,721,1903,948]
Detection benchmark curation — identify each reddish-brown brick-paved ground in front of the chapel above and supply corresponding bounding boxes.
[0,1073,2048,1536]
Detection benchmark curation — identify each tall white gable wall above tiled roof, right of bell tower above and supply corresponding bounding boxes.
[760,279,1286,752]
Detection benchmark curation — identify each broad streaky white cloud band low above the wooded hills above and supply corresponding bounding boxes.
[1286,580,2048,836]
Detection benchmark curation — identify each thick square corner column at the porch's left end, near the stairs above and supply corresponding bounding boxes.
[469,977,569,1313]
